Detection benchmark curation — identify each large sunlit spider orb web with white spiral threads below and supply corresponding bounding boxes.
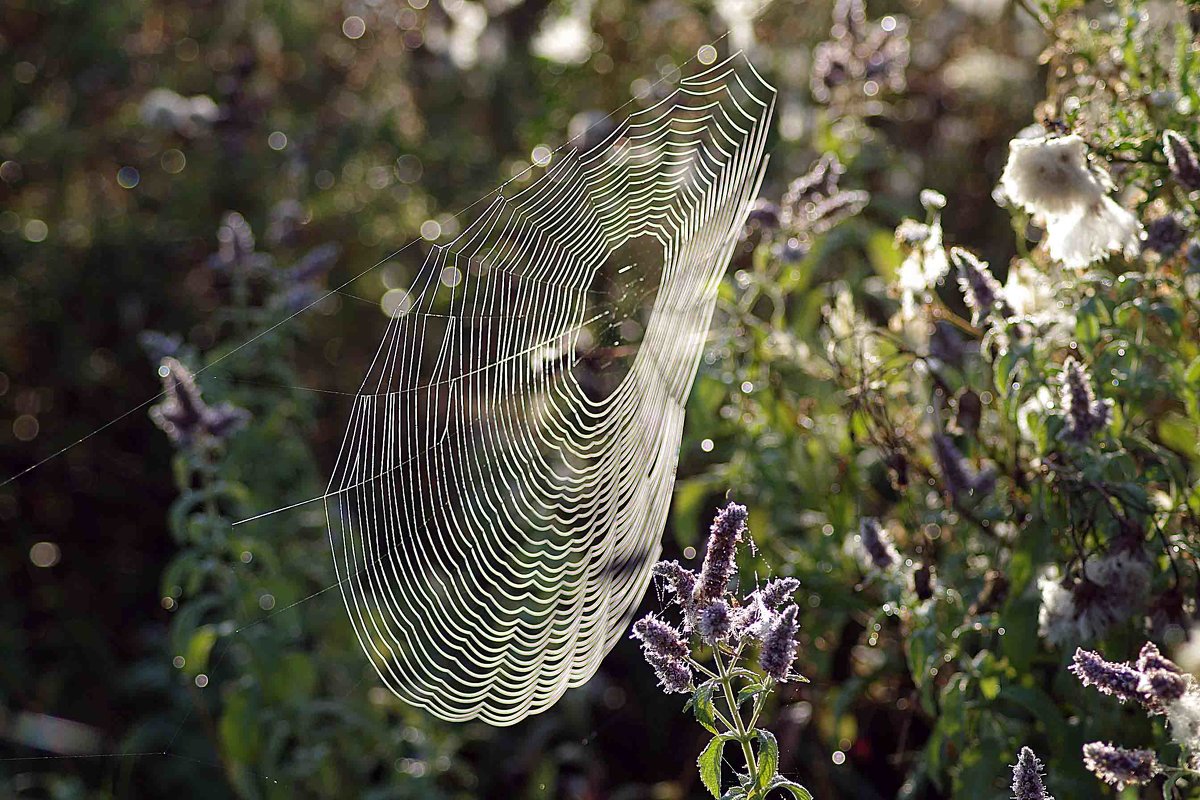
[325,55,774,724]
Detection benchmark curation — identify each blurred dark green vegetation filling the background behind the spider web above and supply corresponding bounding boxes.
[0,0,1200,800]
